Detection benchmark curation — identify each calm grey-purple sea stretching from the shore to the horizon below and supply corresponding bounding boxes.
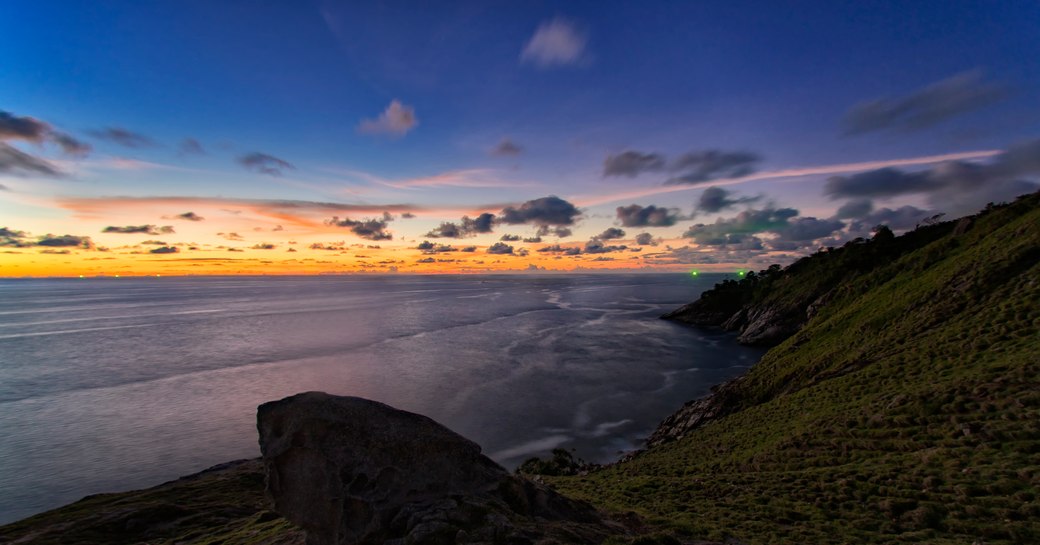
[0,275,761,523]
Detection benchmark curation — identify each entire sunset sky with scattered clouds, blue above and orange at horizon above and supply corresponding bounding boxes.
[0,0,1040,277]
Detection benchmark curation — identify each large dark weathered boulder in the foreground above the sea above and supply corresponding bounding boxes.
[257,392,624,545]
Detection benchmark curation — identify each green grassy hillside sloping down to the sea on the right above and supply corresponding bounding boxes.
[553,194,1040,544]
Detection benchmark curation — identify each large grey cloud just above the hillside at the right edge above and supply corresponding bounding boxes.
[824,139,1040,215]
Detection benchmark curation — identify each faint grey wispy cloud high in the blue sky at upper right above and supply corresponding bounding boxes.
[842,70,1007,134]
